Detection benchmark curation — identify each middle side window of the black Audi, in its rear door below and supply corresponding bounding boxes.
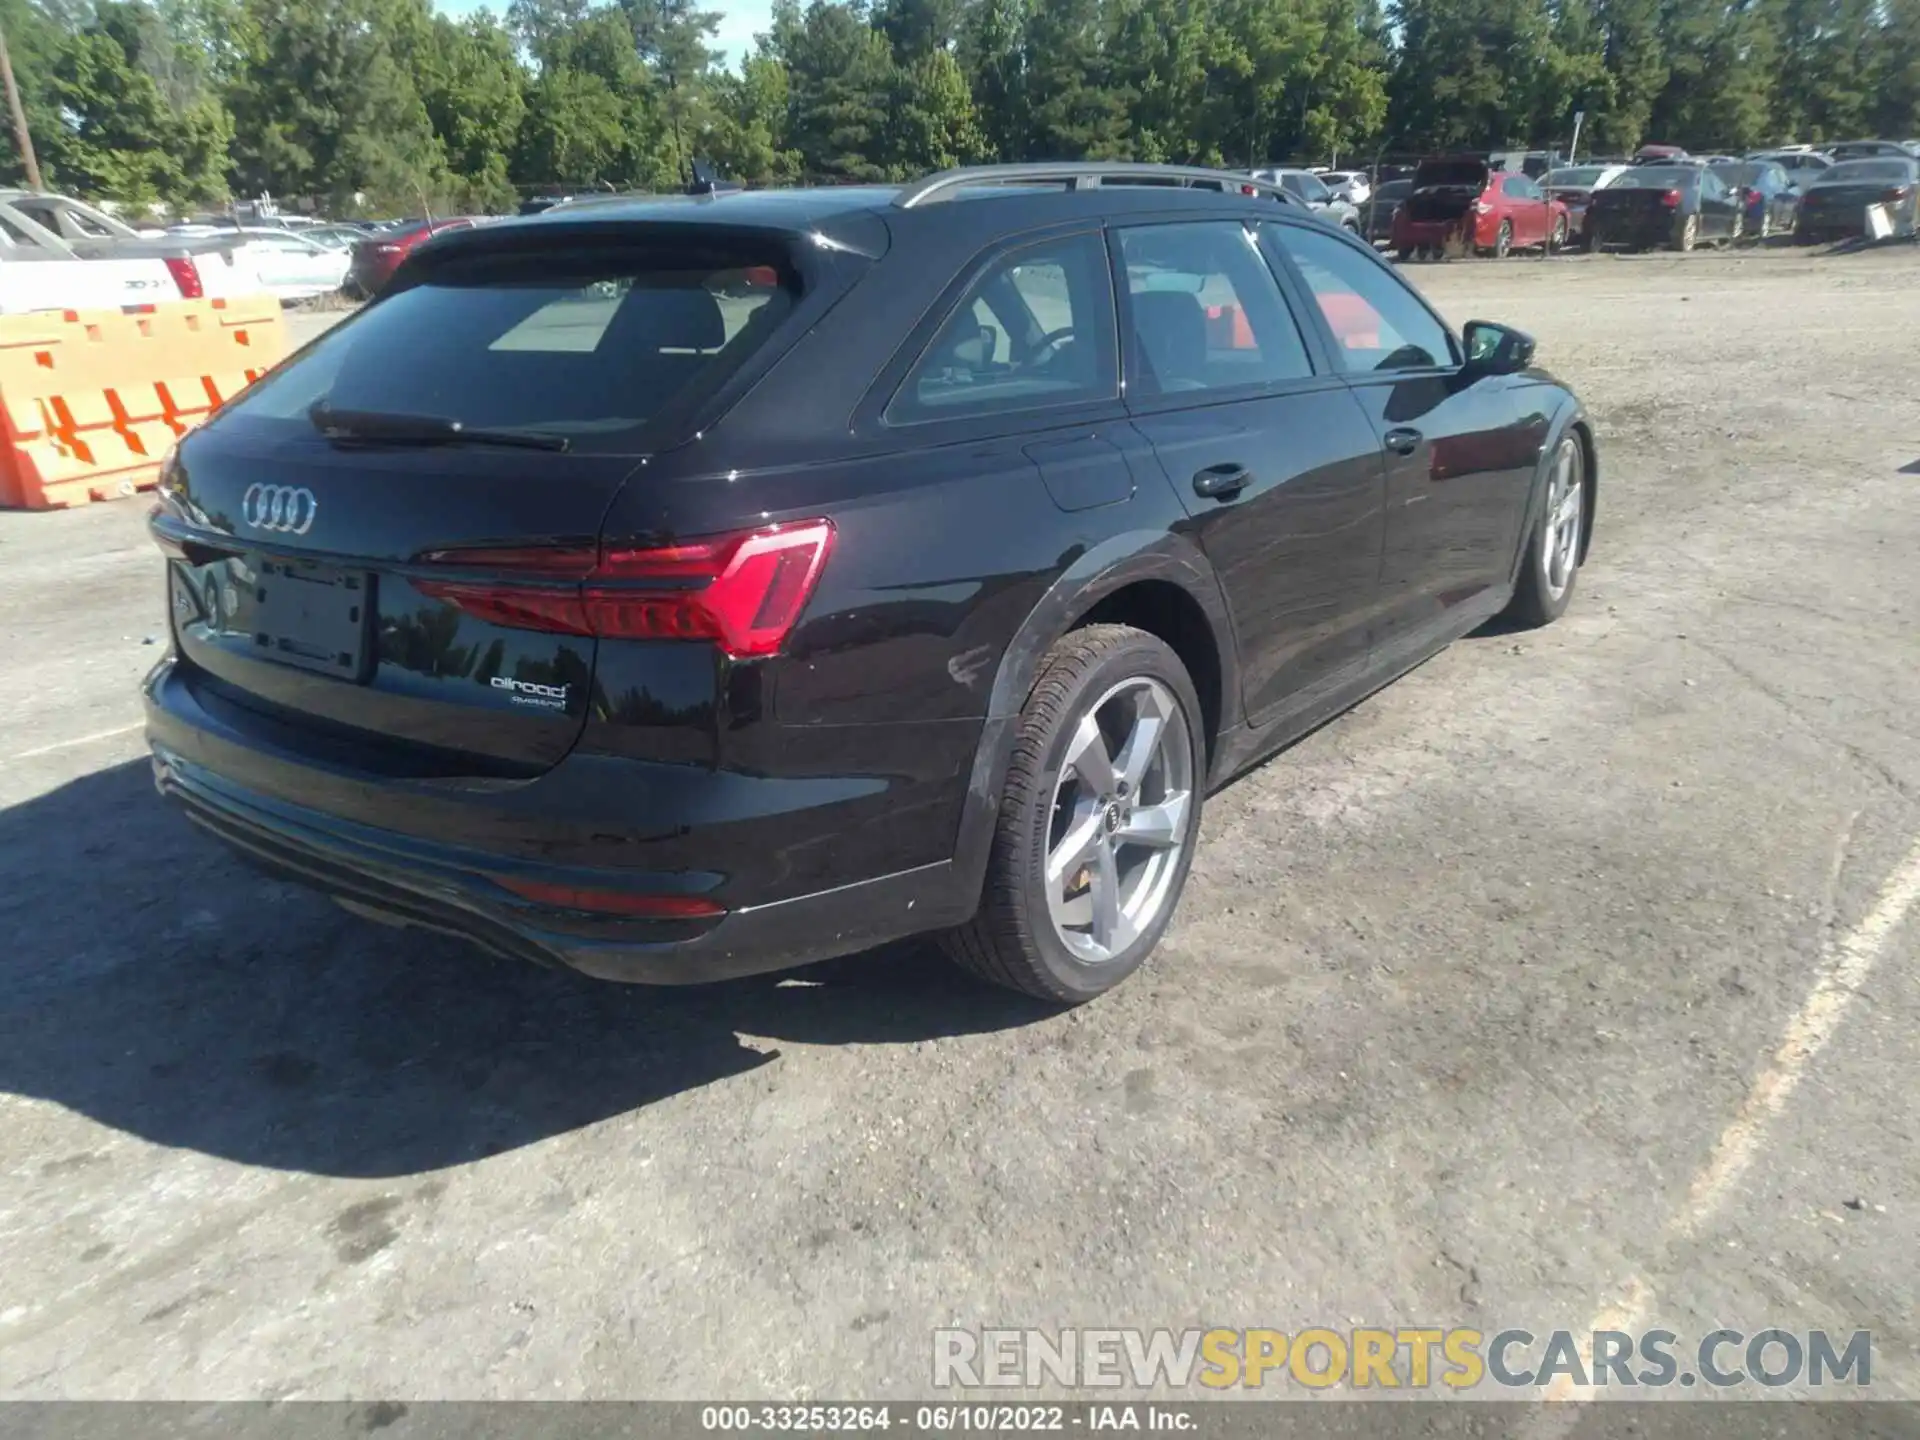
[1119,221,1313,396]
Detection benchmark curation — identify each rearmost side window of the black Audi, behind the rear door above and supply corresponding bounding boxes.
[887,234,1119,424]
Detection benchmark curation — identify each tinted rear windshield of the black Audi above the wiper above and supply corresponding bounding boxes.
[230,250,795,453]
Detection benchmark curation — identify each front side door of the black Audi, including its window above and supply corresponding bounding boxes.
[1267,227,1548,655]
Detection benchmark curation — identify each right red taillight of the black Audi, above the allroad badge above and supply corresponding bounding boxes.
[415,520,833,659]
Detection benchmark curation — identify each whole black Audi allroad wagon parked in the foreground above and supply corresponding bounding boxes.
[144,165,1597,1002]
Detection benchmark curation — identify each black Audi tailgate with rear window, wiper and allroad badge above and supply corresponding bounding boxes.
[154,242,797,772]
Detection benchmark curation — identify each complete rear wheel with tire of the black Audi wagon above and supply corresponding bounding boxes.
[945,626,1206,1004]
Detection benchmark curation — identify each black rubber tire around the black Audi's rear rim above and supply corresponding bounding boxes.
[941,624,1206,1004]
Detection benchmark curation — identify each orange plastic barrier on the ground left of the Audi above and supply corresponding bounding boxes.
[0,296,286,511]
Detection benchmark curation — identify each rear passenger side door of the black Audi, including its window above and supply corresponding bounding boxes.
[1114,219,1384,724]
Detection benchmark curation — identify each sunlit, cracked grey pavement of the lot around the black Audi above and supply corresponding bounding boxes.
[0,246,1920,1400]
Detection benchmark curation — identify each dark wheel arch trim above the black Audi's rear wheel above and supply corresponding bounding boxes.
[954,530,1240,902]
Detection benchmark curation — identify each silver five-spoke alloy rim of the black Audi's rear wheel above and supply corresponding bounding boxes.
[1043,676,1194,964]
